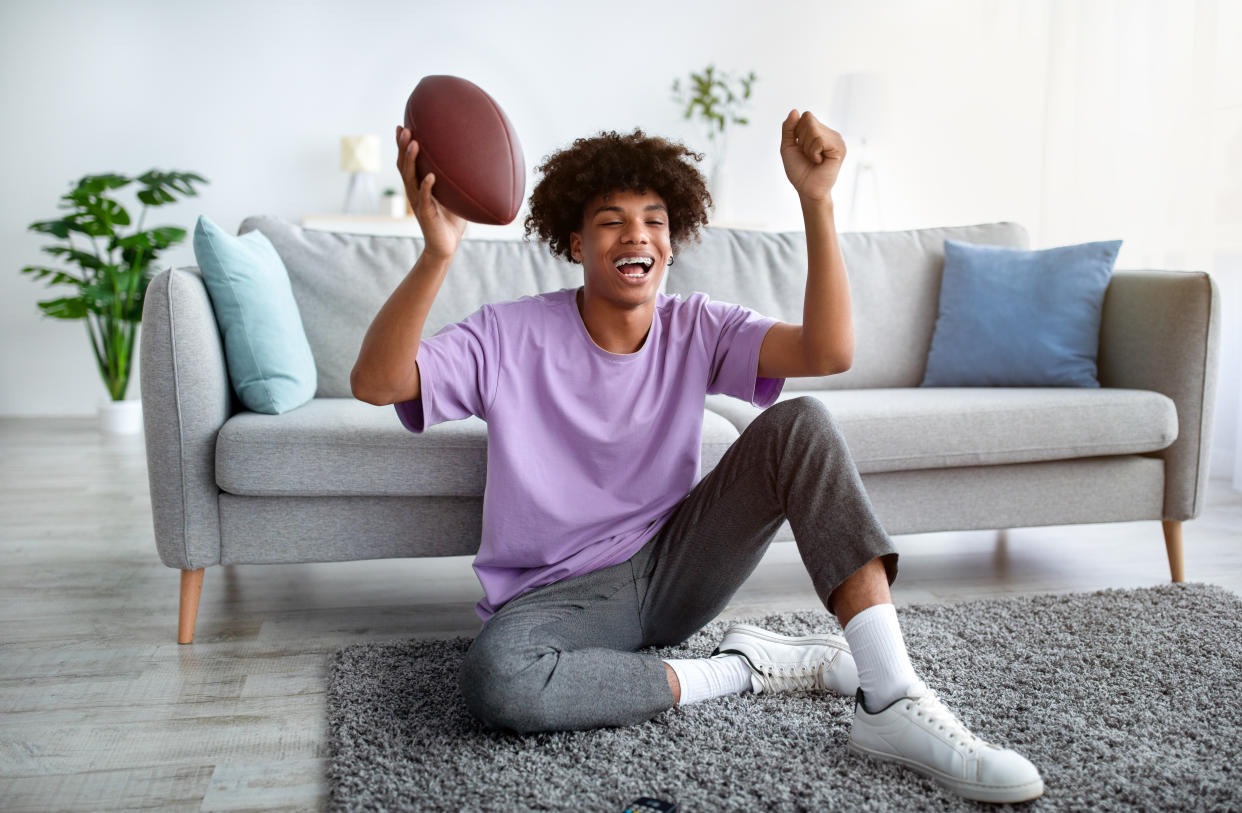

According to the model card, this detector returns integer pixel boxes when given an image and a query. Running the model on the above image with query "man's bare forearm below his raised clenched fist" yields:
[802,199,854,371]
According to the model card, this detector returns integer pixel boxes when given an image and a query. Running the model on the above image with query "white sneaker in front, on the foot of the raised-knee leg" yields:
[850,681,1043,802]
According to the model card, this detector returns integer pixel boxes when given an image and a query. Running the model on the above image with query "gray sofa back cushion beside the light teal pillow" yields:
[240,215,582,398]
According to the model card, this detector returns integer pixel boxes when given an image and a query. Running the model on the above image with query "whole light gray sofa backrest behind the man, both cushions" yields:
[238,215,1028,398]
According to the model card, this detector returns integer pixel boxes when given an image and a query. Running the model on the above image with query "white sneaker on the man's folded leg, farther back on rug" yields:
[712,624,858,698]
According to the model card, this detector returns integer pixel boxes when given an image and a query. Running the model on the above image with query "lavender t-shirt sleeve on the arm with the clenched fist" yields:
[699,299,785,407]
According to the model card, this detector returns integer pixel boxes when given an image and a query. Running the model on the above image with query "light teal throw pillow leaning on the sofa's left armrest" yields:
[194,216,318,415]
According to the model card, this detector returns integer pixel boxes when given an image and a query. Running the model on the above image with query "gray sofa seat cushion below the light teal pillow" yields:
[216,398,740,496]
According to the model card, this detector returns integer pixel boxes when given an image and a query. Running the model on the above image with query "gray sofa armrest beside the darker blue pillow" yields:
[1099,271,1221,520]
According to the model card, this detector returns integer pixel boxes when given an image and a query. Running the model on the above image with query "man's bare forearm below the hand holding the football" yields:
[349,252,452,403]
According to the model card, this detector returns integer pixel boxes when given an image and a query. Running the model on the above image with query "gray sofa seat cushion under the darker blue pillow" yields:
[707,387,1177,474]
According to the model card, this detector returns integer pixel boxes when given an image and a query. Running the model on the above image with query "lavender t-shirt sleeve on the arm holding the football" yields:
[394,305,501,432]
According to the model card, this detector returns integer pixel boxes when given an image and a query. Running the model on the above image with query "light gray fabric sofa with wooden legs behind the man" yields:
[140,216,1220,643]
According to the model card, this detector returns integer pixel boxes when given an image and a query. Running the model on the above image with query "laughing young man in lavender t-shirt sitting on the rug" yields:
[351,110,1043,802]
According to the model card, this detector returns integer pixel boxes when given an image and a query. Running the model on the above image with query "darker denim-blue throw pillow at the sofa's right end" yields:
[923,240,1122,387]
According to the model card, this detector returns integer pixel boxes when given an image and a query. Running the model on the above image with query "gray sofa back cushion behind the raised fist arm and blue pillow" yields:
[668,223,1028,391]
